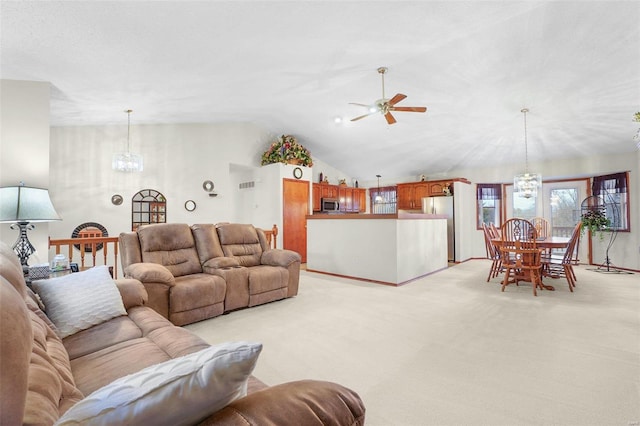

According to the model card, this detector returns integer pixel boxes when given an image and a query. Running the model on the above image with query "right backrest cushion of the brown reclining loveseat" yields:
[217,223,262,266]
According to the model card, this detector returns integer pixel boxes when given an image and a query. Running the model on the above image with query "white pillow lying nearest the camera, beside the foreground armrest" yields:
[56,342,262,425]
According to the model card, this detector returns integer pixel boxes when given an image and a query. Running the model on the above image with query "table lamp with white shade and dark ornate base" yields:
[0,184,60,272]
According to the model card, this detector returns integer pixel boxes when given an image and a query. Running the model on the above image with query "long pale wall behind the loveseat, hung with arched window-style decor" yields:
[50,122,270,238]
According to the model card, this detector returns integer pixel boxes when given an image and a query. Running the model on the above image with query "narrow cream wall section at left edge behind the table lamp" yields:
[0,80,52,265]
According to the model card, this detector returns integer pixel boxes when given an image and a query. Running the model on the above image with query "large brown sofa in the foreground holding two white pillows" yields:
[0,242,365,426]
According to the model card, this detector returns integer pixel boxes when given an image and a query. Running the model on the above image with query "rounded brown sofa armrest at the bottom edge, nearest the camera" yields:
[199,380,365,426]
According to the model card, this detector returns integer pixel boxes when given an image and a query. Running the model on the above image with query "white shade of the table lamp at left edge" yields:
[0,186,61,222]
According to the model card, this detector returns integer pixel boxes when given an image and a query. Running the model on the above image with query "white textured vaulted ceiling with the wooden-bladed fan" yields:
[0,0,640,180]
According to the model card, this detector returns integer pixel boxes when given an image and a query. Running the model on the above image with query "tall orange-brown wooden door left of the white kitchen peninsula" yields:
[282,179,309,263]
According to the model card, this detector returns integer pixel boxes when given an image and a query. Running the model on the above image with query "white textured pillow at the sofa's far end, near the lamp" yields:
[31,266,127,339]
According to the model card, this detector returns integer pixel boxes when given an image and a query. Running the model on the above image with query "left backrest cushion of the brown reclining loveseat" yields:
[138,223,202,277]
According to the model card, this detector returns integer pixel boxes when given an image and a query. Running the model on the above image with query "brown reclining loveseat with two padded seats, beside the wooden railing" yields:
[120,223,300,325]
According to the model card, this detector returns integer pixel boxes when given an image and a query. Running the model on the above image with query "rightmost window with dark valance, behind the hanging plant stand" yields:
[591,172,629,231]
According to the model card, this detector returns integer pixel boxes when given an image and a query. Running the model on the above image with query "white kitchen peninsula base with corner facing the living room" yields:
[307,213,447,286]
